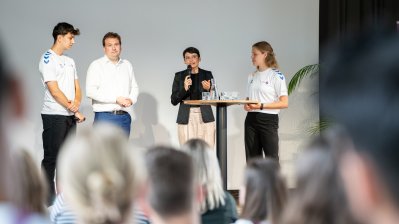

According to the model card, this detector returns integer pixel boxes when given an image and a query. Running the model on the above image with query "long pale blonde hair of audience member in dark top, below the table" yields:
[182,139,225,213]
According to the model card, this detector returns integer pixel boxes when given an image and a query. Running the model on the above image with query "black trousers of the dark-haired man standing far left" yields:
[42,114,76,204]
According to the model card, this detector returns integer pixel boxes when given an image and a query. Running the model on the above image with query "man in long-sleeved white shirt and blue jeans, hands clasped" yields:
[86,32,139,136]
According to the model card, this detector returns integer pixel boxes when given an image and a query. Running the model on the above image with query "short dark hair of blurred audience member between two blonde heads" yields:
[145,146,194,217]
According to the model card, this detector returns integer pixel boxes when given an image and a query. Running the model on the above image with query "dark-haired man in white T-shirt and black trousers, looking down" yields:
[39,23,85,203]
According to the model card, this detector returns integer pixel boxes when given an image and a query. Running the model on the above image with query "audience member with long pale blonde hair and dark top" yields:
[182,139,237,224]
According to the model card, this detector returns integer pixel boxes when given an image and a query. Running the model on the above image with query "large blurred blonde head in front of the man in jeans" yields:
[57,123,139,224]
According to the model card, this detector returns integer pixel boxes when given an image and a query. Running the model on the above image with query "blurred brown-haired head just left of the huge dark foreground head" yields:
[282,128,354,224]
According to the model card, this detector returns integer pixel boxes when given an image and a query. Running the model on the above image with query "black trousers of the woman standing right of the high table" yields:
[244,112,279,161]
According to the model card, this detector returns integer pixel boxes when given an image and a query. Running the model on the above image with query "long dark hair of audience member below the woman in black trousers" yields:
[241,158,287,223]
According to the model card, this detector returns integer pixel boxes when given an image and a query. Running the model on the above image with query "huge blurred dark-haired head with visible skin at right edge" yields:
[320,29,399,223]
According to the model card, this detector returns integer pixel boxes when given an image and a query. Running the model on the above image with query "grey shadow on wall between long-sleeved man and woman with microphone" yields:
[130,93,171,148]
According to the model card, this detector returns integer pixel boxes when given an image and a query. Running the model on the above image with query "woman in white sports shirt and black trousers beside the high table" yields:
[244,41,288,161]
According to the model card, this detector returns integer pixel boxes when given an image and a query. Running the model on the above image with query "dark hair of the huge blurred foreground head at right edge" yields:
[320,30,399,207]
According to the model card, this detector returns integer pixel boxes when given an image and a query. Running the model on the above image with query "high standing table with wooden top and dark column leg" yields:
[184,100,258,190]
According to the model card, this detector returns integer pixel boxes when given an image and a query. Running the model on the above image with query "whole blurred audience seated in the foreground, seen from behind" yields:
[0,27,399,224]
